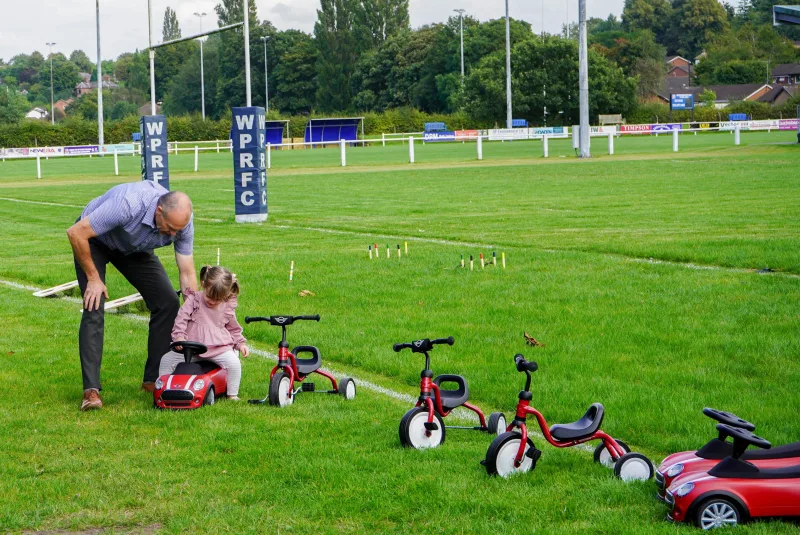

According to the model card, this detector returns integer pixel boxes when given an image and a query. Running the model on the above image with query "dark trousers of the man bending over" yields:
[75,238,180,390]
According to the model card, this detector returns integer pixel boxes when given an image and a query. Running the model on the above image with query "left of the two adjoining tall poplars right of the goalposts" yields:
[314,0,358,112]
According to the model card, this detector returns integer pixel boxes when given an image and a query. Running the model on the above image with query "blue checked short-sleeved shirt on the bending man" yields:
[81,180,194,255]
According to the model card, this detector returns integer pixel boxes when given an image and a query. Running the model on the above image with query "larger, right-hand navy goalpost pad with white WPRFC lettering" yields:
[231,106,267,223]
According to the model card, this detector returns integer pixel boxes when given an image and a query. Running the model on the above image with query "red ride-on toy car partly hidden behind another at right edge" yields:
[656,408,800,500]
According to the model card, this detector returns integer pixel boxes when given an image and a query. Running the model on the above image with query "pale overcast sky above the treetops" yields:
[0,0,624,61]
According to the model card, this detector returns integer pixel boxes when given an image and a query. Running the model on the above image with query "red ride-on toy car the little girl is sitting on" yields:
[153,340,228,409]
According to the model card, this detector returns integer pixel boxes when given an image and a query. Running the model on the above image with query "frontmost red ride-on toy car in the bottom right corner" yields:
[667,424,800,530]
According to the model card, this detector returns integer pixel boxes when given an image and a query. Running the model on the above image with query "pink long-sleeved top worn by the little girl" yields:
[172,288,247,358]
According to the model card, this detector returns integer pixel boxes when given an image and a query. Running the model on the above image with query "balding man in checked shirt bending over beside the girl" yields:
[67,181,197,411]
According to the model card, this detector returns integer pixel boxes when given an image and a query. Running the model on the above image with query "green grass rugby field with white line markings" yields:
[0,132,800,534]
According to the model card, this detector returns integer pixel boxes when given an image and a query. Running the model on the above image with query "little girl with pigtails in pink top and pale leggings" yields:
[158,266,250,401]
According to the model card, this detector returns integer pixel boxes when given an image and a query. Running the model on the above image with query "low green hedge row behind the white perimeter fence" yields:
[0,99,800,147]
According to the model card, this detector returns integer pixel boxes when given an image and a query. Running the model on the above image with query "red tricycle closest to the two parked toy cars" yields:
[481,355,653,481]
